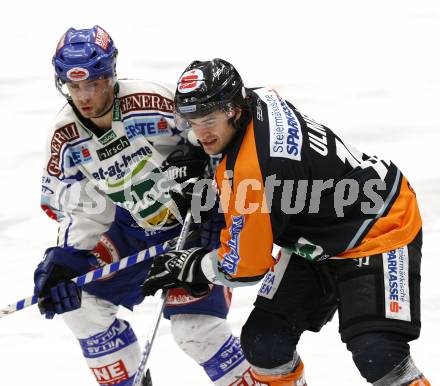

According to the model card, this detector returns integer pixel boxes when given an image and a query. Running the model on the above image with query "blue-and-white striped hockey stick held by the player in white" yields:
[0,243,168,318]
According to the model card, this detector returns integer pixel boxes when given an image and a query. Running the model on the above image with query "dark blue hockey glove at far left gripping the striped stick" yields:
[34,247,98,319]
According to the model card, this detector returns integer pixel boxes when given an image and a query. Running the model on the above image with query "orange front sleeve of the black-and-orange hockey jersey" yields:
[216,124,275,278]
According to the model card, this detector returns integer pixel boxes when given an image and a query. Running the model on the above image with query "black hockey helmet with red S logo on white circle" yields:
[174,58,246,119]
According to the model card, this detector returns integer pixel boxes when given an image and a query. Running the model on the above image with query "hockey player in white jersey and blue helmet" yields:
[34,26,254,386]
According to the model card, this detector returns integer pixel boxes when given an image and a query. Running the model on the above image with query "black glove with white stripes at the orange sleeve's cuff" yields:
[142,248,210,297]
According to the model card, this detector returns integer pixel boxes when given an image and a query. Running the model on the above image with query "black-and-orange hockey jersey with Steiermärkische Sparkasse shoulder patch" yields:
[216,88,422,284]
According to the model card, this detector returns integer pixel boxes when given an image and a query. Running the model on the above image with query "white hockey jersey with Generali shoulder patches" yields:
[41,80,186,250]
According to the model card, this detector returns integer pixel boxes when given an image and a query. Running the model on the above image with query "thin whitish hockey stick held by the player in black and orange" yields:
[132,210,191,386]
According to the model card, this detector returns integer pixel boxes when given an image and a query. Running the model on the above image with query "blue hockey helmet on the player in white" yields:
[52,25,118,91]
